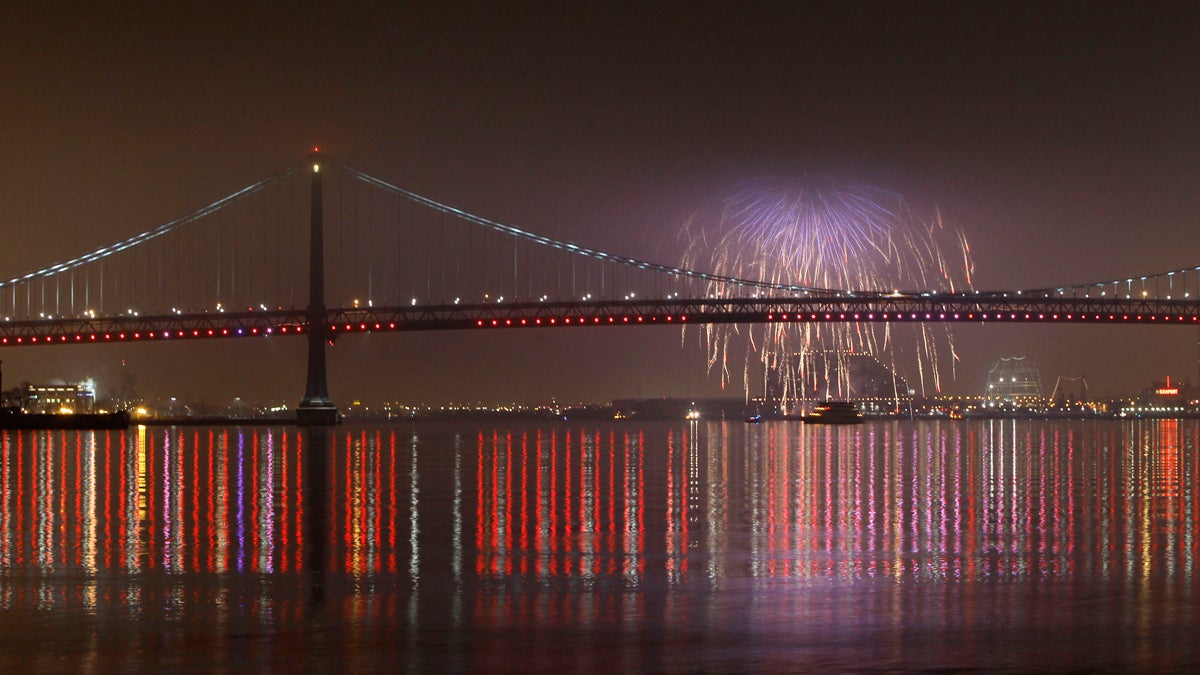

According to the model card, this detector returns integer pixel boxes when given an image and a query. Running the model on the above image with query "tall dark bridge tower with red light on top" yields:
[296,149,341,426]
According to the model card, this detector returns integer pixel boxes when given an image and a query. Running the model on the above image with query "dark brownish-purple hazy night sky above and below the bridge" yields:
[0,2,1200,402]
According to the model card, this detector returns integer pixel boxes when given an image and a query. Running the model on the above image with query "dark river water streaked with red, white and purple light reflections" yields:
[0,420,1200,673]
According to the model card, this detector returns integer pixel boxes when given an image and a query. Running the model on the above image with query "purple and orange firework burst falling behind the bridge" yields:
[682,179,973,406]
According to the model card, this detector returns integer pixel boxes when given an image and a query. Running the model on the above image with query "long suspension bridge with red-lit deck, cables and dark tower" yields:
[0,151,1200,424]
